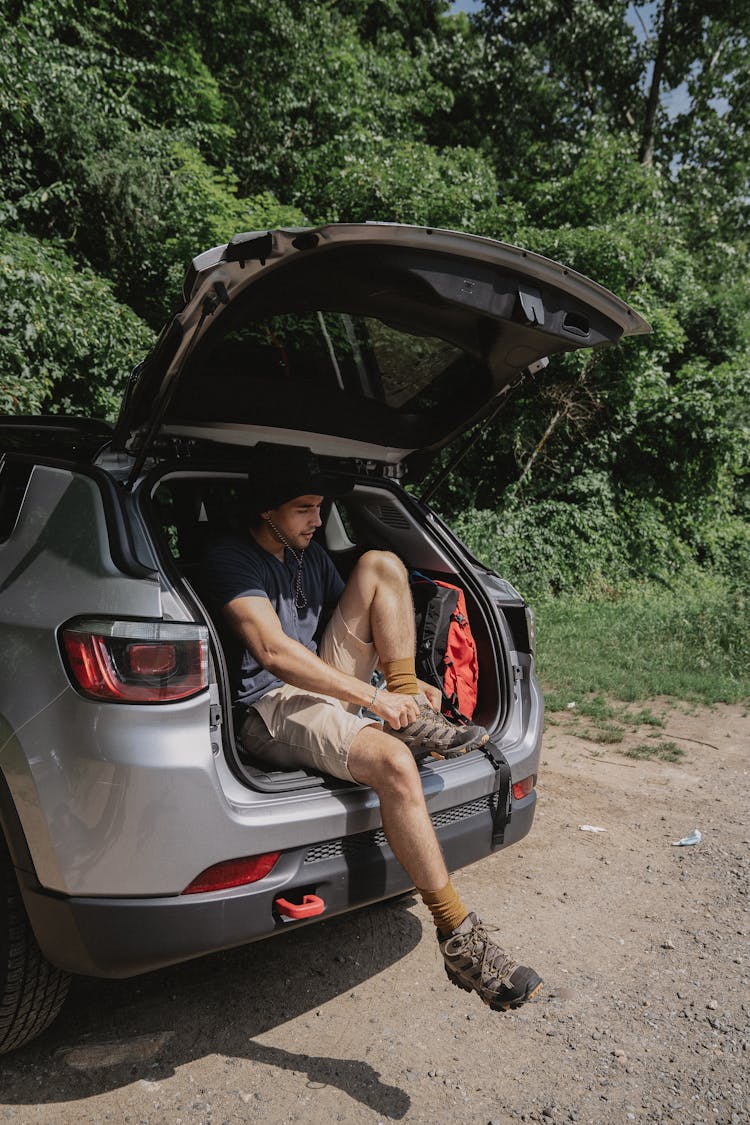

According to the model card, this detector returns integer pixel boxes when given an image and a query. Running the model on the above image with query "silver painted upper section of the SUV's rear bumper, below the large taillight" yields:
[0,657,542,897]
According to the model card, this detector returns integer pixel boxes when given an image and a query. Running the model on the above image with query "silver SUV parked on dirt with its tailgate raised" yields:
[0,224,648,1051]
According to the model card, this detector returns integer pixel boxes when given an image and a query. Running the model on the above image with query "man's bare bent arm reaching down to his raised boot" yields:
[224,597,417,728]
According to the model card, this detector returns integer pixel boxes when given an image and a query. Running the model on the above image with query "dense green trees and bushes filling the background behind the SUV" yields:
[0,0,750,607]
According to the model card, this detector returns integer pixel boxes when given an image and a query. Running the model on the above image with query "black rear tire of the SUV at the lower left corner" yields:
[0,833,70,1054]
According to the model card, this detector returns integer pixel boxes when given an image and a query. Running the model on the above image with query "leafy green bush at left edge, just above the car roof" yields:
[0,234,153,420]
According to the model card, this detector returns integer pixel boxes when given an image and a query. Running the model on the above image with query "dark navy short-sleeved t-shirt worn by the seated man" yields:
[204,536,344,707]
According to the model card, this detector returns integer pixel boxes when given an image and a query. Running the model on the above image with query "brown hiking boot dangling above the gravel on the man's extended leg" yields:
[437,914,542,1011]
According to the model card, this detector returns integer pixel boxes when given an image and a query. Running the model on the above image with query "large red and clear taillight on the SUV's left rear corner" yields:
[61,619,208,703]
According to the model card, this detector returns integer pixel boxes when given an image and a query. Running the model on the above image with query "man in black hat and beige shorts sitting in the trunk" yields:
[207,455,542,1009]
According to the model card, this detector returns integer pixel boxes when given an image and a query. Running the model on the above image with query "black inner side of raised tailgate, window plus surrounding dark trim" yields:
[170,248,498,449]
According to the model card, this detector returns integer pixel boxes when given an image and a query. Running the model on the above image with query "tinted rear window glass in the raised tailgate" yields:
[171,309,491,449]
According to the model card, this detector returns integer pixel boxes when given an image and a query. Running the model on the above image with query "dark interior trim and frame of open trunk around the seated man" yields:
[142,456,530,793]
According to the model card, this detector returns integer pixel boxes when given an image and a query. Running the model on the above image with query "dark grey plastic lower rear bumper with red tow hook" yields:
[19,792,536,978]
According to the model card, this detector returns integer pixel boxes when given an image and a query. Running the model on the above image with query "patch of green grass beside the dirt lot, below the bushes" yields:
[534,574,750,702]
